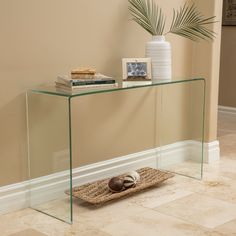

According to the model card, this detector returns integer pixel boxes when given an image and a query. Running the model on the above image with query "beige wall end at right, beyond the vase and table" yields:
[193,0,222,142]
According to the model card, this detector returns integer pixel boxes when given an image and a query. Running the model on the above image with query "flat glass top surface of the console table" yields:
[28,78,205,98]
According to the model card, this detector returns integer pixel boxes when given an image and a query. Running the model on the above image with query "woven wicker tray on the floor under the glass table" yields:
[66,167,174,204]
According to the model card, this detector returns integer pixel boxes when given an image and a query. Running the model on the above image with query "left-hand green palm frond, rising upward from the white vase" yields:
[128,0,165,35]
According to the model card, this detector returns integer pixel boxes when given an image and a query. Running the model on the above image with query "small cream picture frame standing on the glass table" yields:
[122,58,152,81]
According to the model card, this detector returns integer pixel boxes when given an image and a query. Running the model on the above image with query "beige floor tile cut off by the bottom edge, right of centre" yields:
[102,210,214,236]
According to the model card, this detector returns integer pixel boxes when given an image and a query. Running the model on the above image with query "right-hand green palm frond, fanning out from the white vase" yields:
[168,3,216,41]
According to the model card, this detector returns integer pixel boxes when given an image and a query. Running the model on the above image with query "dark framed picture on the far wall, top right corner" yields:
[222,0,236,26]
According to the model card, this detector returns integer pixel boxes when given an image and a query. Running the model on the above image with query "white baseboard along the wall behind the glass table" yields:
[0,140,219,214]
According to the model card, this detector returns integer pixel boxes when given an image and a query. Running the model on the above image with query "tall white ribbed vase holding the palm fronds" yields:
[146,36,171,83]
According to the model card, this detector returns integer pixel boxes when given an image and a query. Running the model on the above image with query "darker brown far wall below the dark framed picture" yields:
[219,26,236,107]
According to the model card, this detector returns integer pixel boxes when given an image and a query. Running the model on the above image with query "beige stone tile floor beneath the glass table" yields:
[0,111,236,236]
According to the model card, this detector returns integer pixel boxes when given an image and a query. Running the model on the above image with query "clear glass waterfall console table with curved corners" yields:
[27,78,205,223]
